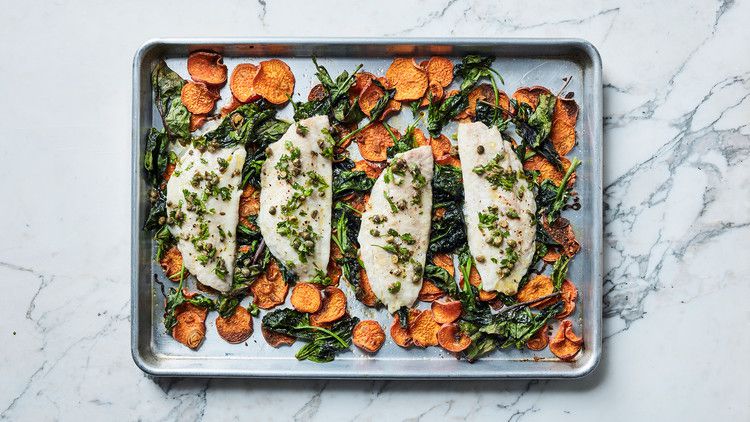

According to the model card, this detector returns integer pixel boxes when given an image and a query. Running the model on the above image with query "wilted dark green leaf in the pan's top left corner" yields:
[151,60,190,144]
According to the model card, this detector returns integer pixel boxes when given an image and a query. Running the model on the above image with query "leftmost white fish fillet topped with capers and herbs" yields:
[167,146,245,292]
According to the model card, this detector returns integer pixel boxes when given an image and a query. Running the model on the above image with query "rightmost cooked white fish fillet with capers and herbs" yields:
[458,122,536,295]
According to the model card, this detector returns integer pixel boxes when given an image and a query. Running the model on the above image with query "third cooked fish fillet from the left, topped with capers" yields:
[358,146,433,312]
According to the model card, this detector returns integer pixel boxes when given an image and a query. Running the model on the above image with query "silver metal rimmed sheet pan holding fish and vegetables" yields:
[131,38,602,379]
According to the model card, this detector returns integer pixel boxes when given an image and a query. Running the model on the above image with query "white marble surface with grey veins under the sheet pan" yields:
[0,0,750,421]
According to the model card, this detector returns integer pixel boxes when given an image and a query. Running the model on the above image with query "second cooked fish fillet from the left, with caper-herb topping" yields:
[258,116,333,282]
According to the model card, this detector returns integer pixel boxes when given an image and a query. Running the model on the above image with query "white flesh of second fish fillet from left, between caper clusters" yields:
[258,116,333,282]
